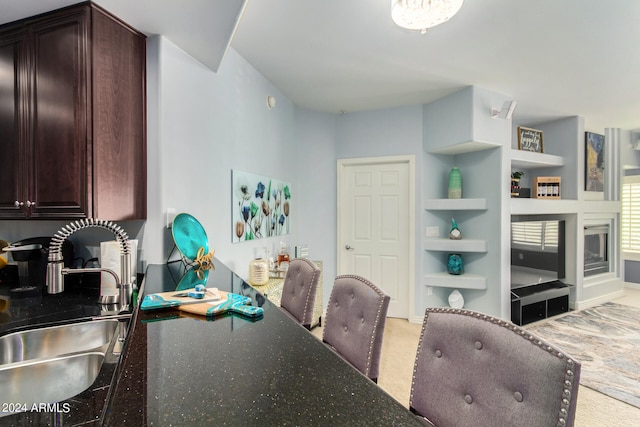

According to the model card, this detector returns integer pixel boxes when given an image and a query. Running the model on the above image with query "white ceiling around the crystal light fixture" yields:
[0,0,640,131]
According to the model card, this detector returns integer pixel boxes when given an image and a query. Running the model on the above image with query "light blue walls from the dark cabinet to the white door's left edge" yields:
[143,37,348,301]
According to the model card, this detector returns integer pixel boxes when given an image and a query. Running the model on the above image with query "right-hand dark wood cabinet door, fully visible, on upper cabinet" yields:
[27,7,91,218]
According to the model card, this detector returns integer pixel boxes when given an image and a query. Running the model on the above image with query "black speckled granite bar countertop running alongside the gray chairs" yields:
[103,259,420,427]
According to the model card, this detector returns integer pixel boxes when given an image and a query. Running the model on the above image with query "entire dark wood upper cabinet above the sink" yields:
[0,3,147,220]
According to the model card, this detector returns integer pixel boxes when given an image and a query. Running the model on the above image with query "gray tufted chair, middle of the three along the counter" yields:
[322,275,390,382]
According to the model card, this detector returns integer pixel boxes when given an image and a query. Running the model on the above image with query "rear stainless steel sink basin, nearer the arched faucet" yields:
[0,319,118,365]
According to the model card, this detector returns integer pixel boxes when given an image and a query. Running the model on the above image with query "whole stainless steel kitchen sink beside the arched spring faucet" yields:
[0,319,122,417]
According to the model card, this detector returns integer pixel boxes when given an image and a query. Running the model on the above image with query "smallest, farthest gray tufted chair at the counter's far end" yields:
[280,258,320,329]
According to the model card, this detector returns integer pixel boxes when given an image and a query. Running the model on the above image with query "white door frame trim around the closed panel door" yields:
[336,154,416,322]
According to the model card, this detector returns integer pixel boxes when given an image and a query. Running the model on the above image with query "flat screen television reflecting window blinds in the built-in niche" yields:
[511,220,565,289]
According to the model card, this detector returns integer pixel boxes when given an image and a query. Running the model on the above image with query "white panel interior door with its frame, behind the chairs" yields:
[337,157,414,319]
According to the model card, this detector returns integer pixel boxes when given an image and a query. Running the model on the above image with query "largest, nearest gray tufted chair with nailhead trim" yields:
[409,308,581,427]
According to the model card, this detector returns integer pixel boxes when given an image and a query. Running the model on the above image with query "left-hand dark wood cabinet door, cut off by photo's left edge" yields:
[0,30,27,218]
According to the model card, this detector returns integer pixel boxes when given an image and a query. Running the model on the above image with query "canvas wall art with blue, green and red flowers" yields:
[231,170,291,243]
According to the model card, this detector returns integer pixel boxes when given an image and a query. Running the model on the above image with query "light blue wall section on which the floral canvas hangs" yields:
[143,37,302,278]
